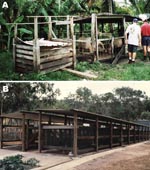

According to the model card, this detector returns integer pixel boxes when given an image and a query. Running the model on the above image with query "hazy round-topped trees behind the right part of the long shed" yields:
[57,87,150,121]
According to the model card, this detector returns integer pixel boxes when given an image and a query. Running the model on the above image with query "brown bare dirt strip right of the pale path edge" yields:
[73,142,150,170]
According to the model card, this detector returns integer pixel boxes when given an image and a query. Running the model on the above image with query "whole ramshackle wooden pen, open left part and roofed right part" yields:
[13,14,138,73]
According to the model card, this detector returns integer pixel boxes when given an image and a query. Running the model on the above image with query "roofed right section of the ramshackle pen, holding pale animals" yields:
[74,13,140,64]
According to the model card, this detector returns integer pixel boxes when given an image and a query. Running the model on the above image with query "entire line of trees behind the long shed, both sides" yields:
[0,82,150,121]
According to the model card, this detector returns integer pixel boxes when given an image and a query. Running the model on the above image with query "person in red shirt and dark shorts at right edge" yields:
[141,18,150,61]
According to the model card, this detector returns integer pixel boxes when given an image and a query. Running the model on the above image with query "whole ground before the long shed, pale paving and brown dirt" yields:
[0,141,150,170]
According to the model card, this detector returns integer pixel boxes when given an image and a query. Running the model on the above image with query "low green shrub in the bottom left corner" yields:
[0,155,39,170]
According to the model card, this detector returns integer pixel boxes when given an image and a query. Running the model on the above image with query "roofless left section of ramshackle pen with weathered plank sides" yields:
[13,16,76,73]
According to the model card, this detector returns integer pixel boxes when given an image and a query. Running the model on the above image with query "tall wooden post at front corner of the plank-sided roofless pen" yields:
[33,17,40,72]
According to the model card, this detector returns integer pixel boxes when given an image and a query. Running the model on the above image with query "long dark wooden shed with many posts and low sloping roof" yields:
[0,109,150,156]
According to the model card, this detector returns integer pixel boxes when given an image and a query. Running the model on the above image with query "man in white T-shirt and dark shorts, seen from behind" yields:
[125,18,141,64]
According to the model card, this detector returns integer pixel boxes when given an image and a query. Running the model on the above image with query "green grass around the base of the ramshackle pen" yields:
[0,52,150,81]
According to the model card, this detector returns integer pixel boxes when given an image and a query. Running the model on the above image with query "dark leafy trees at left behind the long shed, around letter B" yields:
[0,82,60,113]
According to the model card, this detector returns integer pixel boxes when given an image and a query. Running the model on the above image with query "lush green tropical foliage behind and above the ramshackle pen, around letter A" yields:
[0,0,150,50]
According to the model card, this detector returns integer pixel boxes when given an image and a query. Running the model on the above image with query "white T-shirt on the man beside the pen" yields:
[126,23,141,46]
